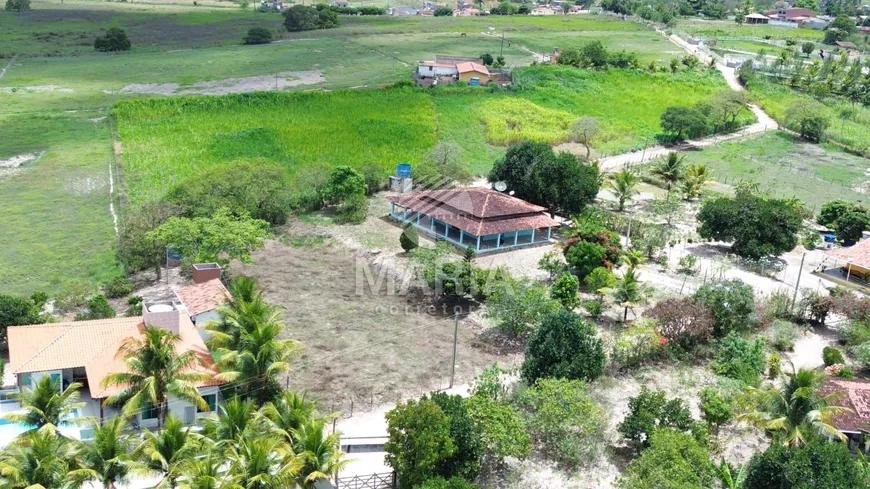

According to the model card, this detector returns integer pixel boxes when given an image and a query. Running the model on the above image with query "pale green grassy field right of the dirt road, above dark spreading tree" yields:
[686,132,870,209]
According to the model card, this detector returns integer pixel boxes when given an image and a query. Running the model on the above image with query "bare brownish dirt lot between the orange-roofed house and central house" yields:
[233,222,516,415]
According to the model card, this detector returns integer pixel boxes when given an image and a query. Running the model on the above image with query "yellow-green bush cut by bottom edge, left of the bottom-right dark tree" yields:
[619,428,718,489]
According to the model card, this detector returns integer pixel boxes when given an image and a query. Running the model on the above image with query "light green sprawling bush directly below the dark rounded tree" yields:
[516,379,607,467]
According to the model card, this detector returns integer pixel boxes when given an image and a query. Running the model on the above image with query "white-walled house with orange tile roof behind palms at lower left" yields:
[3,303,223,430]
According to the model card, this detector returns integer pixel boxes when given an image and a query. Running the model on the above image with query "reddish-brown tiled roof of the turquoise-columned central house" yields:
[386,187,559,236]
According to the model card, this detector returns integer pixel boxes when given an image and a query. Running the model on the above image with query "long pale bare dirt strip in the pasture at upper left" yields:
[116,70,326,95]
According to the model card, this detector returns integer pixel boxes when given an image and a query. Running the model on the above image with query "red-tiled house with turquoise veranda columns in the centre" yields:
[386,188,559,253]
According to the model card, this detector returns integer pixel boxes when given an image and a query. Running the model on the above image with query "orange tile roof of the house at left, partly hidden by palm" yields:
[7,313,222,399]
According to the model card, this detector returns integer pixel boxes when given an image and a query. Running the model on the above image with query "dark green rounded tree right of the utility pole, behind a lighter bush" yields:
[522,309,606,384]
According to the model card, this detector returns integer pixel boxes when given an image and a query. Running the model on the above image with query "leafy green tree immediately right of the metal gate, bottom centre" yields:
[384,399,456,487]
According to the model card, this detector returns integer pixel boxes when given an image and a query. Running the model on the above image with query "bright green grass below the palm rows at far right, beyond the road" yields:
[749,77,870,154]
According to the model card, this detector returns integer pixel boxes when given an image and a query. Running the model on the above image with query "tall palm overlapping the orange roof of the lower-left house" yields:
[103,326,211,428]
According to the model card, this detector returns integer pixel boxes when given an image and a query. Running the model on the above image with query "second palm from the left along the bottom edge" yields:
[73,416,138,489]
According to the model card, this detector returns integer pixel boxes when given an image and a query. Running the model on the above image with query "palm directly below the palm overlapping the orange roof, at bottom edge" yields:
[140,416,203,489]
